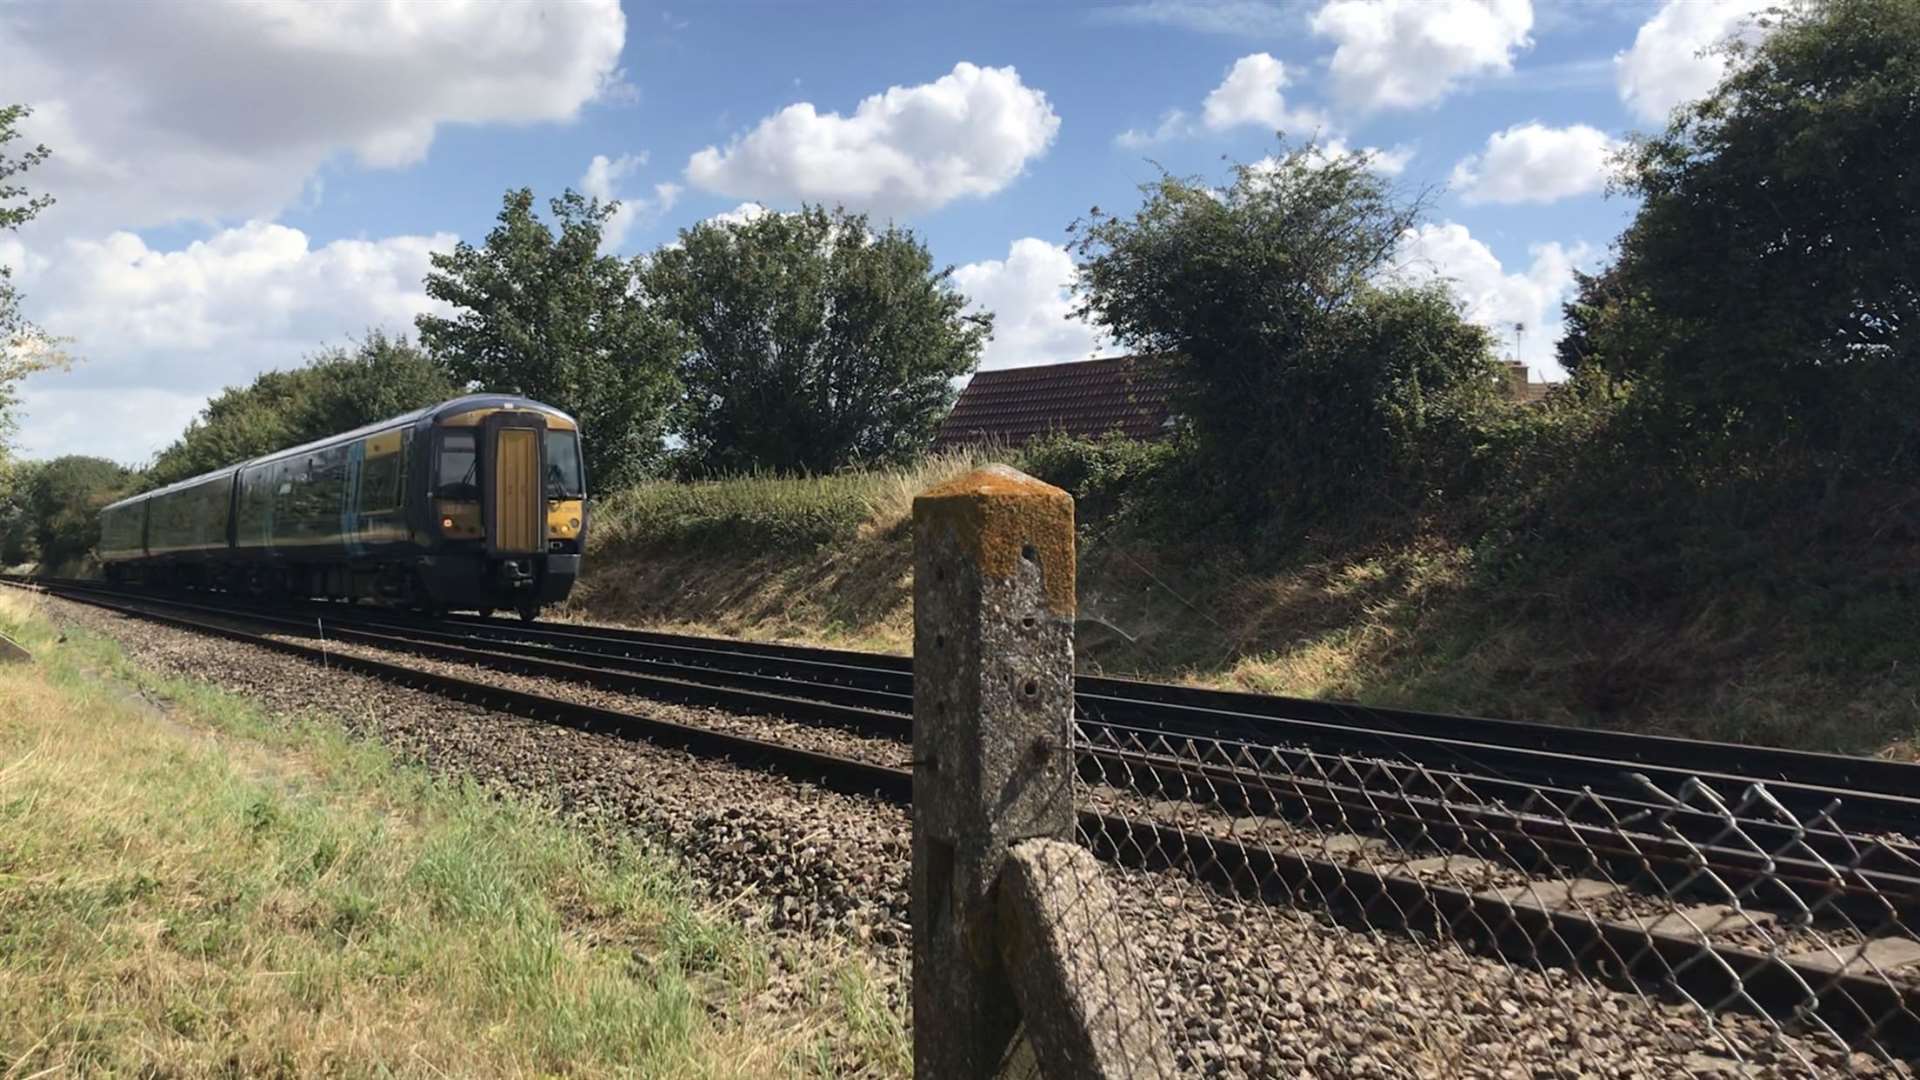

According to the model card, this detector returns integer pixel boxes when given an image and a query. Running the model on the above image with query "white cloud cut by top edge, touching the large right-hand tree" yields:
[1613,0,1778,123]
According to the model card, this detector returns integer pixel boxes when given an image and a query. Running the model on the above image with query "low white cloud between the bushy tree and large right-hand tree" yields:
[1394,221,1594,379]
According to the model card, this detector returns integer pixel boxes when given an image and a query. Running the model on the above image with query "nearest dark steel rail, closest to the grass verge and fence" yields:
[11,576,1920,1055]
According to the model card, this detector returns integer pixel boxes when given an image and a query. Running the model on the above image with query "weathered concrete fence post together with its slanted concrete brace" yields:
[912,465,1171,1080]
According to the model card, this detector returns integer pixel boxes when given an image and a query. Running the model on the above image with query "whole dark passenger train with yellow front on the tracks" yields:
[96,394,588,621]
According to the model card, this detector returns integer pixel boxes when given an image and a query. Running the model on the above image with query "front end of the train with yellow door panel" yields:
[420,398,586,621]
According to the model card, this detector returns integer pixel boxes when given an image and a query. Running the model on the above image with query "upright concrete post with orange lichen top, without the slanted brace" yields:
[912,465,1073,1078]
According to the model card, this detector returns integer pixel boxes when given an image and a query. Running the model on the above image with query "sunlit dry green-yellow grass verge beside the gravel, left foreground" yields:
[0,590,906,1076]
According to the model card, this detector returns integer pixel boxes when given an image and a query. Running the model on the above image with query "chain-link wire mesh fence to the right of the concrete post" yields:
[1073,715,1920,1076]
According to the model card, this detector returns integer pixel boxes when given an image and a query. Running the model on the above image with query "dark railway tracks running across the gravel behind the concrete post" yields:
[15,582,1920,1053]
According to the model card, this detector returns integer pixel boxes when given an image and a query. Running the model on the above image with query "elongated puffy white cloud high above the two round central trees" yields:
[687,61,1060,213]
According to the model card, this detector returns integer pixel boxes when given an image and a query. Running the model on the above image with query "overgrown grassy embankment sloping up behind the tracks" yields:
[572,457,1920,755]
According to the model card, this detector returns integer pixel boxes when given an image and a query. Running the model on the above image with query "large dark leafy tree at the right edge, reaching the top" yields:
[1576,0,1920,471]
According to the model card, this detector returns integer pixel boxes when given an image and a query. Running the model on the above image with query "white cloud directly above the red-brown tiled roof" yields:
[954,236,1102,367]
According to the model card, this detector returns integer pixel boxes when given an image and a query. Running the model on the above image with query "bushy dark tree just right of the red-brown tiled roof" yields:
[1073,144,1498,517]
